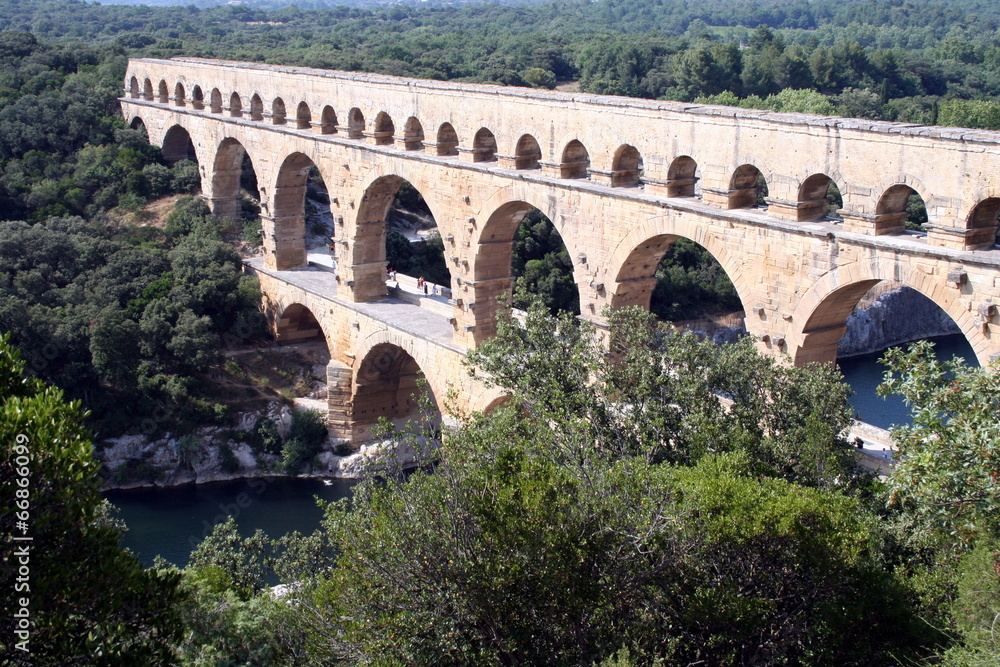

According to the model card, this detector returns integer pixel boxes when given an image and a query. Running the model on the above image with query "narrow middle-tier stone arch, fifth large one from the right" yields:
[267,152,327,270]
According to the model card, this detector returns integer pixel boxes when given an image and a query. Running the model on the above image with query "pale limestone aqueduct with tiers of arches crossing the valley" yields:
[121,58,1000,438]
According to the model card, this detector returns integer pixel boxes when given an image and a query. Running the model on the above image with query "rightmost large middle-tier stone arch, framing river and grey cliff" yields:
[787,259,989,366]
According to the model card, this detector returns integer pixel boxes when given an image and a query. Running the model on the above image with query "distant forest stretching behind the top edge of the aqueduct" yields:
[0,0,1000,128]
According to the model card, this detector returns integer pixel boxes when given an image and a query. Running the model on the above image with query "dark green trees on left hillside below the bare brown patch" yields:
[0,198,261,434]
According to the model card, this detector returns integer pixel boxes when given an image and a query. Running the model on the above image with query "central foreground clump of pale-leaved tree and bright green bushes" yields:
[272,303,926,665]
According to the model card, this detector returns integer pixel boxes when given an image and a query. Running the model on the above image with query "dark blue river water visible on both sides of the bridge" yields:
[106,335,975,566]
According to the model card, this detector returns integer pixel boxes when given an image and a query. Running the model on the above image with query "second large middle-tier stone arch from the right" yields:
[606,218,754,322]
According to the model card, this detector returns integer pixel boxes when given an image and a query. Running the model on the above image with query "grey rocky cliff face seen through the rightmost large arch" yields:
[837,287,961,357]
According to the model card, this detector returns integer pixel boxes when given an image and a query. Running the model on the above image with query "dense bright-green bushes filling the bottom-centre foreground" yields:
[306,426,916,665]
